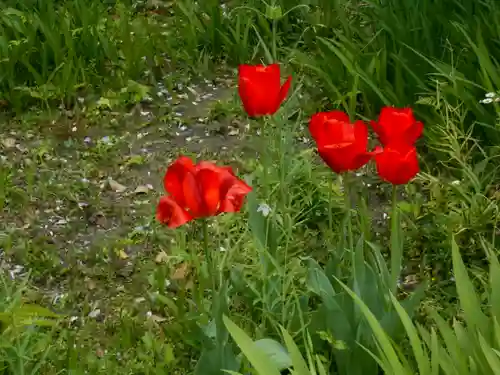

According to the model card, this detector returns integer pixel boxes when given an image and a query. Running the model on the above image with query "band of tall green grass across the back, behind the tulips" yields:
[0,0,500,148]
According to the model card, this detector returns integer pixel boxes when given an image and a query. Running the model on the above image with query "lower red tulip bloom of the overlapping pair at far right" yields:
[373,145,420,185]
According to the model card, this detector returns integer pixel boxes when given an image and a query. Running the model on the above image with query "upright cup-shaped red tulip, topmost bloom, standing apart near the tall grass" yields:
[238,64,292,117]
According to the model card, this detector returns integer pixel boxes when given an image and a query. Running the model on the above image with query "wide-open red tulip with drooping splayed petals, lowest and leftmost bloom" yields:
[156,156,252,228]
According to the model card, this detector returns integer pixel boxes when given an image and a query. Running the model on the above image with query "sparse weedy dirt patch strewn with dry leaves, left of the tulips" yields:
[0,72,252,314]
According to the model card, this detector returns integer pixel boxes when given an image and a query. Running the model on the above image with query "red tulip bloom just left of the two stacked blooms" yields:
[309,111,372,173]
